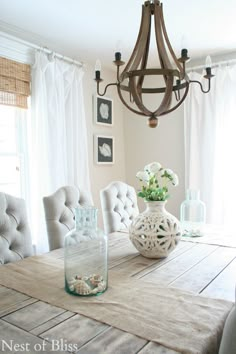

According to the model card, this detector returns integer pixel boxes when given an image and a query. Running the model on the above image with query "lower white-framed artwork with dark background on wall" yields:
[94,135,115,164]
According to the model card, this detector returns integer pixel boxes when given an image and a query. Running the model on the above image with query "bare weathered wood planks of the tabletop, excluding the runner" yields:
[0,233,236,354]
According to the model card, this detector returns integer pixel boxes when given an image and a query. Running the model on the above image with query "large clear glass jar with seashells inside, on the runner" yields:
[64,207,108,296]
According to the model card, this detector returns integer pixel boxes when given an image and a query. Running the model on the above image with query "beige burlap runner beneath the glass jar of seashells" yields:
[0,256,232,354]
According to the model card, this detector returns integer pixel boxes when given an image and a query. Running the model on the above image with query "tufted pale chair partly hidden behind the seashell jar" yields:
[43,186,92,251]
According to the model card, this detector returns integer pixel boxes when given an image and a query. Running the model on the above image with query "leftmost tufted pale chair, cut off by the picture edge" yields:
[0,192,33,264]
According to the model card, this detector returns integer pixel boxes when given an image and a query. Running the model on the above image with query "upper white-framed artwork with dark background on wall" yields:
[94,95,114,126]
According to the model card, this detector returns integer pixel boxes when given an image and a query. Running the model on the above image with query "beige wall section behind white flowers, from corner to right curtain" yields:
[124,82,184,217]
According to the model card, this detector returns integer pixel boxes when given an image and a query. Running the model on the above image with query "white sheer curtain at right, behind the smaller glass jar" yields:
[185,65,236,227]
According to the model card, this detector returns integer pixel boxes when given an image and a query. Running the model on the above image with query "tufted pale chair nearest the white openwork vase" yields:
[100,181,139,234]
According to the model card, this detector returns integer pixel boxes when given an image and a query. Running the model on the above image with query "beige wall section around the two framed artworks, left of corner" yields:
[83,65,126,227]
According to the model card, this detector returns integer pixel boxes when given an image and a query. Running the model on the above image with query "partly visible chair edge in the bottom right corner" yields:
[219,289,236,354]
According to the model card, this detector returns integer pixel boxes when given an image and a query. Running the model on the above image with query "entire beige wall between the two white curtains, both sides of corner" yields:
[83,65,184,227]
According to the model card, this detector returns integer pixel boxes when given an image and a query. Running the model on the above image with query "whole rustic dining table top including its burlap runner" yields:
[0,231,236,354]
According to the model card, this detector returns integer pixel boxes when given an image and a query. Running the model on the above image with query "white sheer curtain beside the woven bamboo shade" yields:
[30,51,90,252]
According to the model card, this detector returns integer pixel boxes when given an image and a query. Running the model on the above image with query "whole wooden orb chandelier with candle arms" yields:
[95,0,214,128]
